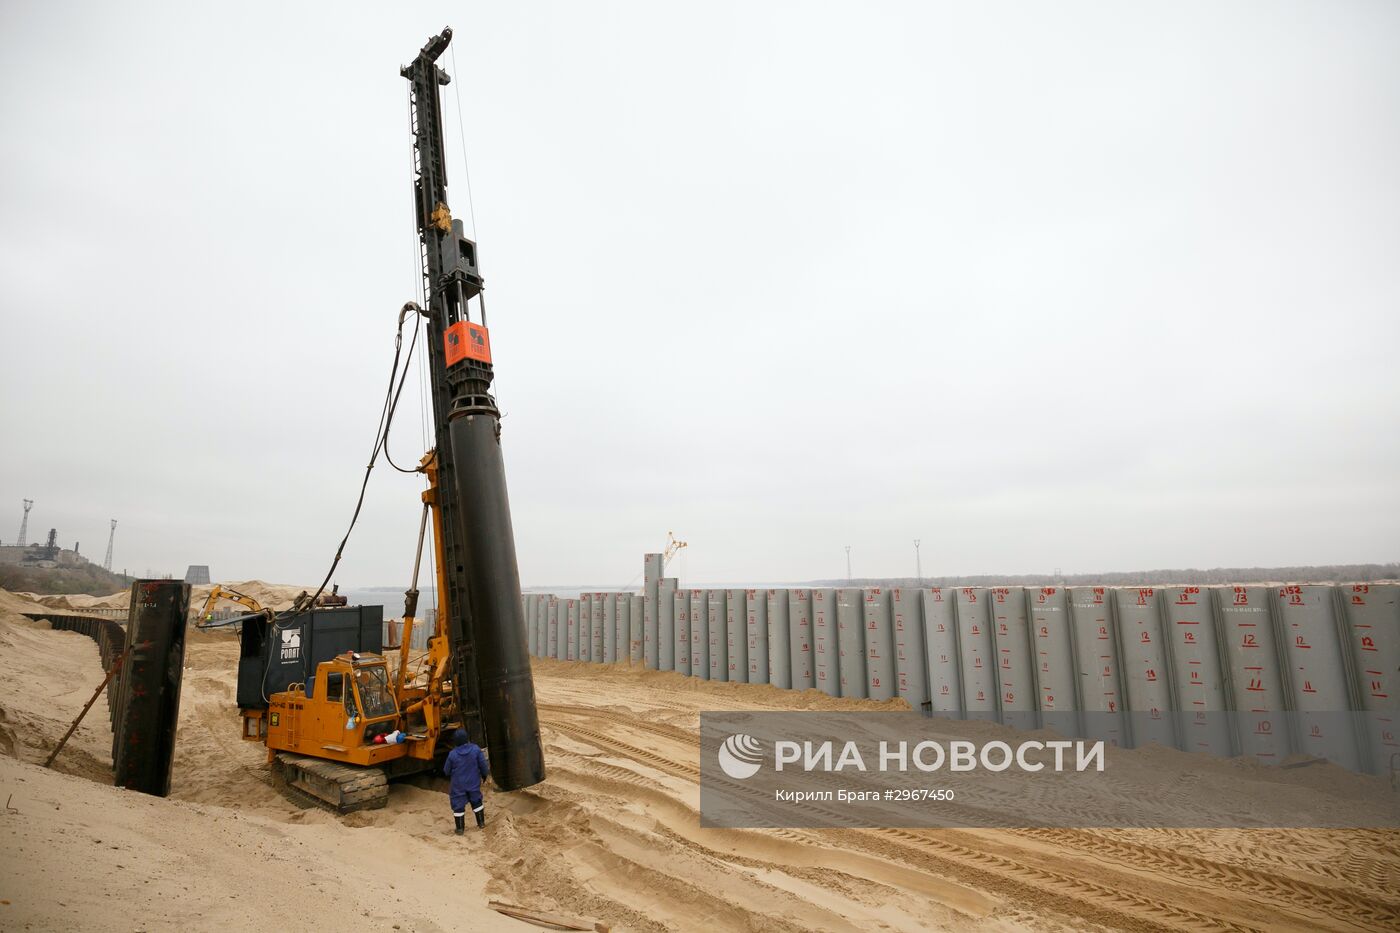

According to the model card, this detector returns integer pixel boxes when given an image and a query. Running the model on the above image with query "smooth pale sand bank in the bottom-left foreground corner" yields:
[0,756,515,933]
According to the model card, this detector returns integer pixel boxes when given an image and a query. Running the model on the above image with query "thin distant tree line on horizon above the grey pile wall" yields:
[811,563,1400,587]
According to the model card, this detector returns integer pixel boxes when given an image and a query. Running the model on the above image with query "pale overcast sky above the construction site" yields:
[0,0,1400,586]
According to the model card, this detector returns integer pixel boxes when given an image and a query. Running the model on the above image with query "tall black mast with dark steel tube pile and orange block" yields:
[399,28,545,790]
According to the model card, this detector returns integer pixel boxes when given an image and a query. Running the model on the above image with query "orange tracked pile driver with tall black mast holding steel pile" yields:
[239,29,545,811]
